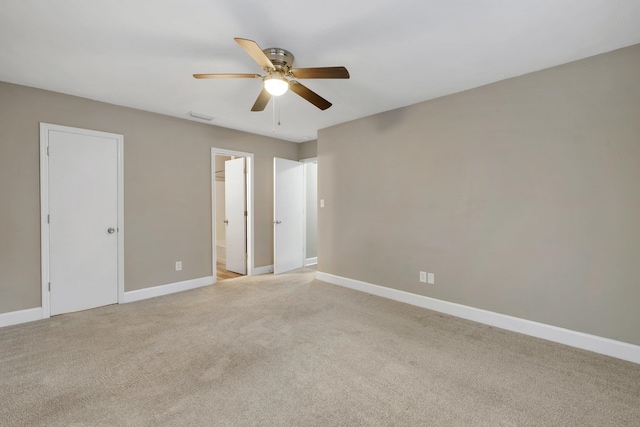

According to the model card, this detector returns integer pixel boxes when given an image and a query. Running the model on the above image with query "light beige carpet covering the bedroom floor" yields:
[0,269,640,426]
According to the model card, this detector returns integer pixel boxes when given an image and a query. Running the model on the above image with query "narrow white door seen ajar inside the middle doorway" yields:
[224,157,247,274]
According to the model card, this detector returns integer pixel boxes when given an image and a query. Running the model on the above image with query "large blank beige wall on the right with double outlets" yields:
[318,45,640,344]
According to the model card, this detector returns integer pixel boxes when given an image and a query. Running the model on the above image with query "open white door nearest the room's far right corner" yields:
[273,157,304,274]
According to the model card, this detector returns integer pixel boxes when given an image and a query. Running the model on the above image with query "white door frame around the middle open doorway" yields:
[211,147,255,283]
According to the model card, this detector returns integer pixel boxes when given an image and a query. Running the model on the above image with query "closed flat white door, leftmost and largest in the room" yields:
[48,128,118,315]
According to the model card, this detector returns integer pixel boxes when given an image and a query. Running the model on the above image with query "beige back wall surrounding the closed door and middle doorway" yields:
[0,83,298,313]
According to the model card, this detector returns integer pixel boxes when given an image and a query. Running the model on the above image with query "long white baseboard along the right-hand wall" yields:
[316,271,640,363]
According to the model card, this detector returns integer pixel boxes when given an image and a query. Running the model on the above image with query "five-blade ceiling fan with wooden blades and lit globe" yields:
[193,37,349,111]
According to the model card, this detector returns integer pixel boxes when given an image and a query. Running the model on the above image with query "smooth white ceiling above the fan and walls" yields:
[0,0,640,142]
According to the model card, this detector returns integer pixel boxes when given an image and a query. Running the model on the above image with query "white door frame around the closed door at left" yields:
[40,122,125,319]
